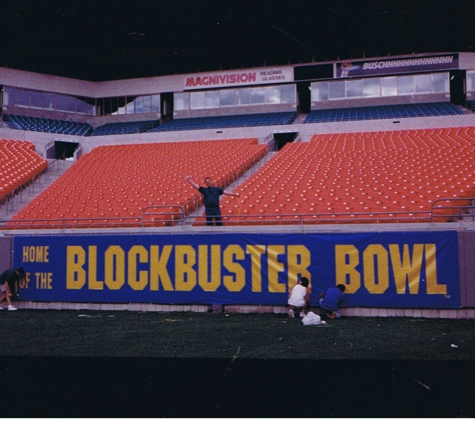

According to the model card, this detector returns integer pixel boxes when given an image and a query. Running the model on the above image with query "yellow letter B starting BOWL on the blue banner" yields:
[335,245,361,293]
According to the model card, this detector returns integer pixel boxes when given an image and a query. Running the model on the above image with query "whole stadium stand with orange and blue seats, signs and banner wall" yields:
[0,52,475,318]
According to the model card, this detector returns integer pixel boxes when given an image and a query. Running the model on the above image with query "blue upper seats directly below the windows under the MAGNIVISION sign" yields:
[150,111,296,132]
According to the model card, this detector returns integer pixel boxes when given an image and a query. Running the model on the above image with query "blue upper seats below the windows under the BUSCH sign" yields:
[304,102,466,123]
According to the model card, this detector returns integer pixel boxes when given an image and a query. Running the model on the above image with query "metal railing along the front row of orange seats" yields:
[0,197,475,230]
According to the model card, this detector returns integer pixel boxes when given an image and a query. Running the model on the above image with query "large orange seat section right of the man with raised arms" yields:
[214,127,475,224]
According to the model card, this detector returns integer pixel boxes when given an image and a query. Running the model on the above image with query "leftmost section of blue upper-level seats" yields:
[3,114,92,136]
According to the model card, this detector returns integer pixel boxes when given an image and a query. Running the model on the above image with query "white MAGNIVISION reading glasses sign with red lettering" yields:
[183,67,294,90]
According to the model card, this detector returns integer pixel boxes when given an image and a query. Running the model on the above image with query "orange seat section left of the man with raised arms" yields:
[8,138,267,227]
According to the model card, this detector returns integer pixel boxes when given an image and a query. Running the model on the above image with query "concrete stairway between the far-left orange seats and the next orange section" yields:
[0,160,74,226]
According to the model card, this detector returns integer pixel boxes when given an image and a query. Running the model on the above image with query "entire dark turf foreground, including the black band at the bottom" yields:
[0,310,475,418]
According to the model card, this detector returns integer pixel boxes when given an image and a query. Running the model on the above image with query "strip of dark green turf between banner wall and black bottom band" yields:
[0,310,475,360]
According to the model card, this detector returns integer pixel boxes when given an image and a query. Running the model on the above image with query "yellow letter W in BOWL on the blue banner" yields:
[389,244,424,295]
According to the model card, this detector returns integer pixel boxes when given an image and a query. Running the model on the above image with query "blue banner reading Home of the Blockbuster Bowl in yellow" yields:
[14,232,460,308]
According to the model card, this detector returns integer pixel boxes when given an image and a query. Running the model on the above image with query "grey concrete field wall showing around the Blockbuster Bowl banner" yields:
[0,223,475,319]
